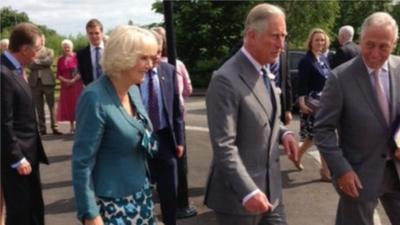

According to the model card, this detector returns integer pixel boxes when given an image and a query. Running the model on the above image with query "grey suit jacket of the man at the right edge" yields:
[314,56,400,200]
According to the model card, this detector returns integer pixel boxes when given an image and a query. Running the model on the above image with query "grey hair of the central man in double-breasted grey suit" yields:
[244,3,285,33]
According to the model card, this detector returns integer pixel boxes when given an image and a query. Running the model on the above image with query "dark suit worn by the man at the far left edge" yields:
[0,54,48,225]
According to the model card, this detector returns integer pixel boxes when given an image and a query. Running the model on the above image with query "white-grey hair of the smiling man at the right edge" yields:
[361,12,399,41]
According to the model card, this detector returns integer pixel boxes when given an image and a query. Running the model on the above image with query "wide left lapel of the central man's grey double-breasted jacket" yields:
[236,51,272,117]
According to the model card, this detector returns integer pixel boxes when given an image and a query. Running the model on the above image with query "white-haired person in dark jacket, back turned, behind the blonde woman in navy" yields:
[331,25,360,69]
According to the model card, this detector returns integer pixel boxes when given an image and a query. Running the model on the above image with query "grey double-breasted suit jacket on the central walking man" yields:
[205,51,287,214]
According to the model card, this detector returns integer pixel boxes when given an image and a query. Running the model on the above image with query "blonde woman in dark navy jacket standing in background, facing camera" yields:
[295,28,330,181]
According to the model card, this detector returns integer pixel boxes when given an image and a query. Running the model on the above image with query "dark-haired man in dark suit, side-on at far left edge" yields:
[0,23,48,225]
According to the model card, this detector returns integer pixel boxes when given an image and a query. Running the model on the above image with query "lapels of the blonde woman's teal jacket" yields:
[99,76,144,133]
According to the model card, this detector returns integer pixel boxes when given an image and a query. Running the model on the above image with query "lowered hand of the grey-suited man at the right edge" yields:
[337,170,363,198]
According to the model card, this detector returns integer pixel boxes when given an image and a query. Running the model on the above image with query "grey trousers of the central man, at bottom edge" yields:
[215,201,287,225]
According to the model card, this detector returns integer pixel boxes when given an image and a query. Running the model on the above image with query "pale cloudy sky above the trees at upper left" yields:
[0,0,164,36]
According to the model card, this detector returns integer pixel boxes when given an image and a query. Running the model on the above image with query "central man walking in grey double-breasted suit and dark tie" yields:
[205,3,298,225]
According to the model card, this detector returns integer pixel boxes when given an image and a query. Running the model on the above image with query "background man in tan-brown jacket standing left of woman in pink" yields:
[28,35,61,135]
